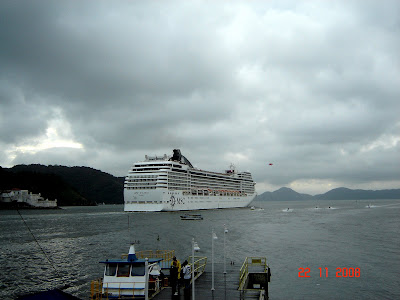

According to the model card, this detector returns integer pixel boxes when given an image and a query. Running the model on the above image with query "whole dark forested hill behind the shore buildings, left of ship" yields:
[0,164,124,206]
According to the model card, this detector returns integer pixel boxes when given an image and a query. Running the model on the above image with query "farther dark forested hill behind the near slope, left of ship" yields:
[4,164,124,205]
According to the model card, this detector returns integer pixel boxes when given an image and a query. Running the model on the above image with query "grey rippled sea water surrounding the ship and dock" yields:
[0,200,400,299]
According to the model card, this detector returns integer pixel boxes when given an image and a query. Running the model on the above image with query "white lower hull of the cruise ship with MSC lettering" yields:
[124,189,256,211]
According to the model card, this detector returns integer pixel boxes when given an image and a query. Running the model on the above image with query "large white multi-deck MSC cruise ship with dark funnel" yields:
[124,149,257,211]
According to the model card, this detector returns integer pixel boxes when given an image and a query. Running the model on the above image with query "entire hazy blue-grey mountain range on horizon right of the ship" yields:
[255,187,400,201]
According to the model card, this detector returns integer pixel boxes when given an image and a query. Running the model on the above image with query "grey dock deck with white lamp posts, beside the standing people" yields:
[153,262,243,300]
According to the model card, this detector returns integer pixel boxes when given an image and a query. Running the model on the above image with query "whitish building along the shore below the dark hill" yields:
[0,189,57,208]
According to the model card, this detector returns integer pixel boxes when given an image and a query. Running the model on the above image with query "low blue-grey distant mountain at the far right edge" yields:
[314,187,400,200]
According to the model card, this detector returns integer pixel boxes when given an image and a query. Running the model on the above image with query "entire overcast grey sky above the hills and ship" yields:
[0,0,400,194]
